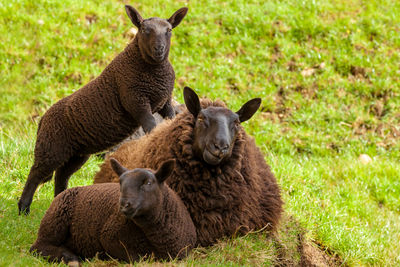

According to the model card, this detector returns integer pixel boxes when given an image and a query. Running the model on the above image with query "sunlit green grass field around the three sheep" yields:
[0,0,400,266]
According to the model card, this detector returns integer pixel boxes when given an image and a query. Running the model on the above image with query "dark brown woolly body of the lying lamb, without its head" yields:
[31,183,196,262]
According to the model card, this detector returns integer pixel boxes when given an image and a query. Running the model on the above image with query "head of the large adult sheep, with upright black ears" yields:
[183,87,261,166]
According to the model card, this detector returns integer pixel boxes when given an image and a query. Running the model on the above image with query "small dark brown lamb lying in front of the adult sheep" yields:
[30,159,196,265]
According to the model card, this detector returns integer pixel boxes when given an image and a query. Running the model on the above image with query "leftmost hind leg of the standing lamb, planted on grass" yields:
[18,163,54,215]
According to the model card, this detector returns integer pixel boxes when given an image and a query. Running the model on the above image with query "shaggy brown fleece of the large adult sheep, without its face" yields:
[94,99,283,246]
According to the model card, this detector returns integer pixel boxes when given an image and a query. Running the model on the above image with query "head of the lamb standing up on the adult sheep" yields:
[125,5,188,64]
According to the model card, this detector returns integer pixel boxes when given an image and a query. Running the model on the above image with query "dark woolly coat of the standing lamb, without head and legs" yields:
[35,39,175,159]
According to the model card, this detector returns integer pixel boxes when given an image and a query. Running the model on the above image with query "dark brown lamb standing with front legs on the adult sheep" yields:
[18,5,188,214]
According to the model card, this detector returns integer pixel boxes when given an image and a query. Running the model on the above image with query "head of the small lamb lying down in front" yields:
[110,158,175,219]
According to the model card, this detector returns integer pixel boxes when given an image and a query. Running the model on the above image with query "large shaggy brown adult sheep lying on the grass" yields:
[94,87,283,246]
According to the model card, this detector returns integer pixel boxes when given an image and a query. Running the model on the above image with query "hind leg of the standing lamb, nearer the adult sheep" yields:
[54,155,89,197]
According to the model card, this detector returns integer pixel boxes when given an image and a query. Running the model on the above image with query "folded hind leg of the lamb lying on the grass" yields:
[30,242,80,264]
